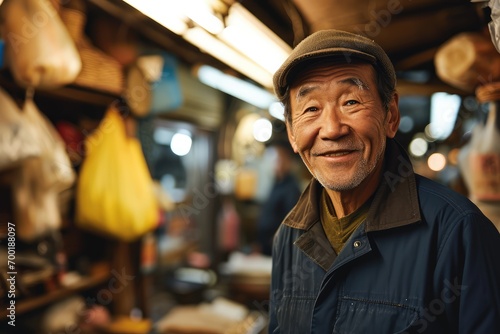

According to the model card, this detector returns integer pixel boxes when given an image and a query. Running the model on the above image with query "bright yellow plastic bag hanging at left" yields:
[76,107,159,241]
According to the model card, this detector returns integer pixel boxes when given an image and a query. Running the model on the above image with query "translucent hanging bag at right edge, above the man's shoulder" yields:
[459,83,500,231]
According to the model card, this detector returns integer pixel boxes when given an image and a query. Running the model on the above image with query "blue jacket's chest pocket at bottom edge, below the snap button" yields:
[333,297,418,334]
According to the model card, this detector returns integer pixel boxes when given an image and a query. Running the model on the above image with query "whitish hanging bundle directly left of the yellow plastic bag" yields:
[12,97,76,241]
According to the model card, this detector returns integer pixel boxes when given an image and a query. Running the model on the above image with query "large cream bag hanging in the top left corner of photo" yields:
[0,0,82,88]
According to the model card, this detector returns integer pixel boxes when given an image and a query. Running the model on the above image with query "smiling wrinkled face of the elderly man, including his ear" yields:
[287,63,399,191]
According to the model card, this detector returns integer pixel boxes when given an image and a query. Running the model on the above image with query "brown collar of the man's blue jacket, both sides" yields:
[283,139,421,232]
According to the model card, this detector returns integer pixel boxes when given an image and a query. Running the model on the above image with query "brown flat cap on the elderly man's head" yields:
[273,29,396,99]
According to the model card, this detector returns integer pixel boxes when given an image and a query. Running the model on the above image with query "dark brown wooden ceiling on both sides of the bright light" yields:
[88,0,489,91]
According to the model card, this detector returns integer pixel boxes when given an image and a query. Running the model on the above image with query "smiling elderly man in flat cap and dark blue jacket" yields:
[269,30,500,334]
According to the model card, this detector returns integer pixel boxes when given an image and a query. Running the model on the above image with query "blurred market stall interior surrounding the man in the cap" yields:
[0,0,500,333]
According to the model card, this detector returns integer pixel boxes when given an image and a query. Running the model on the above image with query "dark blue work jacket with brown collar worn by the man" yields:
[269,140,500,334]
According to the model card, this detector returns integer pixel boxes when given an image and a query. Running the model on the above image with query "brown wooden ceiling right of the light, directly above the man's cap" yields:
[248,0,486,70]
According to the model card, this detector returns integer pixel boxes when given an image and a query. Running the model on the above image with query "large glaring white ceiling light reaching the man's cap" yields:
[123,0,292,88]
